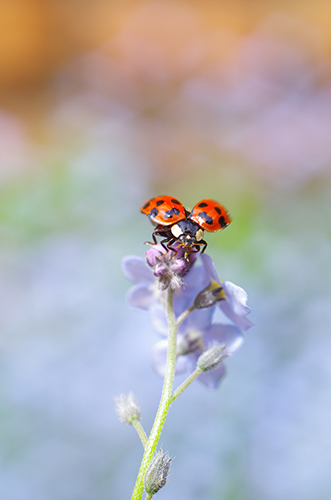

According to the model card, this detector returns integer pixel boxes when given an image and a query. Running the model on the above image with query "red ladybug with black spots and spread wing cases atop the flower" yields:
[141,196,231,259]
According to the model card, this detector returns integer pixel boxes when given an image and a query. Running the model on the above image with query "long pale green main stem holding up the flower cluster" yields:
[132,287,177,500]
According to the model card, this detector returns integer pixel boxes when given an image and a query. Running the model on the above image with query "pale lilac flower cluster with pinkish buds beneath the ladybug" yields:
[123,245,253,388]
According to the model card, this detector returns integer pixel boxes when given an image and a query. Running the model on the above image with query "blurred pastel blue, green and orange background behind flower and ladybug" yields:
[0,0,331,500]
